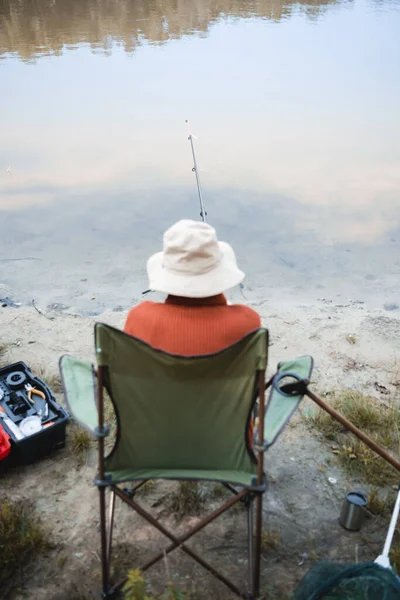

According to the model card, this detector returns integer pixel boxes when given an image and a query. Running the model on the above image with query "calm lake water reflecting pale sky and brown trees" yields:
[0,0,400,313]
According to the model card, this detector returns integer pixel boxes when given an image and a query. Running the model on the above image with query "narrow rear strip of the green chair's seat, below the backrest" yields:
[106,469,256,488]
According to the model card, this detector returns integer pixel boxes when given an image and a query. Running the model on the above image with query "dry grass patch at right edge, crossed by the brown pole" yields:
[306,390,400,486]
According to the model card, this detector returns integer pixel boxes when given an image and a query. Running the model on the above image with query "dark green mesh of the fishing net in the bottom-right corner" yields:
[293,562,400,600]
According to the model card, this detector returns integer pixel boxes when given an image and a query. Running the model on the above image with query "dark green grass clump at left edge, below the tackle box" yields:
[0,497,49,592]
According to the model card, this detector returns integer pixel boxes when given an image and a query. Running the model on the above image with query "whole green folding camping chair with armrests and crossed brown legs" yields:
[60,323,312,599]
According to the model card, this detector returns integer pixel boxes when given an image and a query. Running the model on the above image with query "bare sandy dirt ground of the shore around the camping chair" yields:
[0,299,400,600]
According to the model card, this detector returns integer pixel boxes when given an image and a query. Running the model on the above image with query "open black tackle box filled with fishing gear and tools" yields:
[0,361,68,467]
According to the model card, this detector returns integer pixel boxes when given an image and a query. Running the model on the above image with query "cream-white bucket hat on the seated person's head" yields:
[147,219,244,298]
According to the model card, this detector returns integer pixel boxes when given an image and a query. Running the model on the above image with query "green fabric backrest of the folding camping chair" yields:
[95,323,268,473]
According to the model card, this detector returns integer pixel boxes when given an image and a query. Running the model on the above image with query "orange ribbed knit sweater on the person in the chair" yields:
[124,294,261,356]
